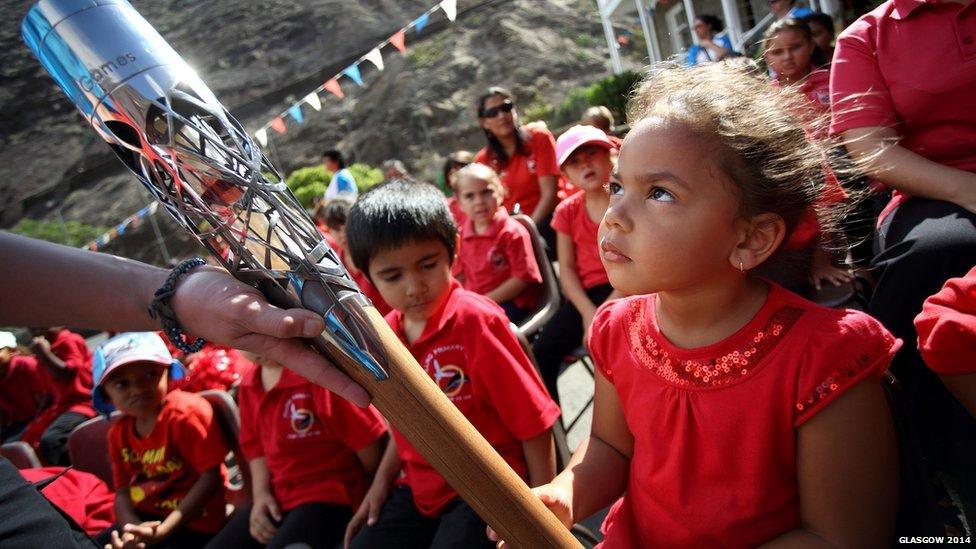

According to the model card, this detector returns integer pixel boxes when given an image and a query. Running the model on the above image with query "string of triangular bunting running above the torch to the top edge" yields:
[254,0,457,147]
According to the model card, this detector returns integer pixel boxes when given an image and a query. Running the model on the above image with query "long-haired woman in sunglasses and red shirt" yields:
[475,86,559,250]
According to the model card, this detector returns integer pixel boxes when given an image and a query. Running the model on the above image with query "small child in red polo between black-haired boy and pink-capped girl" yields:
[457,163,542,322]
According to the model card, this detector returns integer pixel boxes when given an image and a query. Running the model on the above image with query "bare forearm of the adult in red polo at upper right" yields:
[841,126,976,212]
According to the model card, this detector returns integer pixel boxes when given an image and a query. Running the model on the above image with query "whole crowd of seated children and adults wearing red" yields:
[0,0,976,548]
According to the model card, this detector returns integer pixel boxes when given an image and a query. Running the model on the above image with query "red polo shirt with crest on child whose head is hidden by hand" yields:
[237,368,386,511]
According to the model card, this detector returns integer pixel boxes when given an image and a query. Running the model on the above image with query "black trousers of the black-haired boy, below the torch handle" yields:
[350,486,495,549]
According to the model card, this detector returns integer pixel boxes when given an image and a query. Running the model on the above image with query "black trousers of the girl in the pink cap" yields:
[532,284,613,403]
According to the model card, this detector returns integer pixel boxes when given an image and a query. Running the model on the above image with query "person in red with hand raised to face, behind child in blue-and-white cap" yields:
[25,326,95,465]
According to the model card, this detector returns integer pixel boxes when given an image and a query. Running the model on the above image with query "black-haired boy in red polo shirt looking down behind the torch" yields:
[346,182,559,548]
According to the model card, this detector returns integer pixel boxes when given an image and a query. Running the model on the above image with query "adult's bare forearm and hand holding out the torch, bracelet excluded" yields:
[0,232,369,406]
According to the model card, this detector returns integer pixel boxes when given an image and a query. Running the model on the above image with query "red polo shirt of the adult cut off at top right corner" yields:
[830,0,976,221]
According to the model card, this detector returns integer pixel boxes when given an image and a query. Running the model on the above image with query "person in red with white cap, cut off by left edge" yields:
[0,332,50,442]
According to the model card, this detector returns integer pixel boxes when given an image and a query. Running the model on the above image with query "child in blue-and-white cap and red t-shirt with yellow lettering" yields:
[92,332,228,548]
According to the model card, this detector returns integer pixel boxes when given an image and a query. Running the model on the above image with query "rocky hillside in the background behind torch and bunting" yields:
[0,0,636,262]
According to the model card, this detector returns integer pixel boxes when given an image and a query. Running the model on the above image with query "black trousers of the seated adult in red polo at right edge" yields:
[868,198,976,501]
